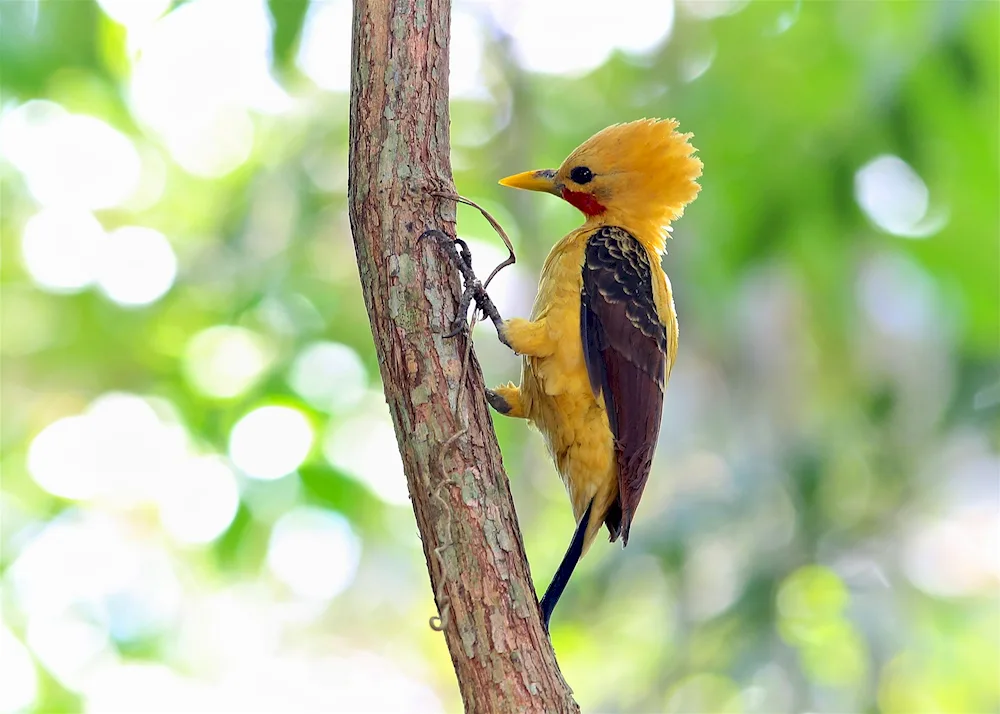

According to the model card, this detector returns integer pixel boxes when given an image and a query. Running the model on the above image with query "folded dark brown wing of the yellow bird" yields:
[580,226,667,544]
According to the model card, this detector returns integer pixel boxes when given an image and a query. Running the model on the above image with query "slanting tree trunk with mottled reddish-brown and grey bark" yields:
[349,0,578,712]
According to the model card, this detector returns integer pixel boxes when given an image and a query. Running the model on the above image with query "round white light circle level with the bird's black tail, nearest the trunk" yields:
[267,507,361,601]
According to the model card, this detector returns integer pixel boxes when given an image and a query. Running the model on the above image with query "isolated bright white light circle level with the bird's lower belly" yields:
[229,406,313,480]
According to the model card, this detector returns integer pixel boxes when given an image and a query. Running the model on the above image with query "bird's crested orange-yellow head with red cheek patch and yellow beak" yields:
[500,119,702,253]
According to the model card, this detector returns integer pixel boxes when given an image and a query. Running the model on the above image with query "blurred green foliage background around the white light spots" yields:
[0,0,1000,714]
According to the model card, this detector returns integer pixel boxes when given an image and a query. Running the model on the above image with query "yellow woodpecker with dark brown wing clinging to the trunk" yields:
[430,119,702,631]
